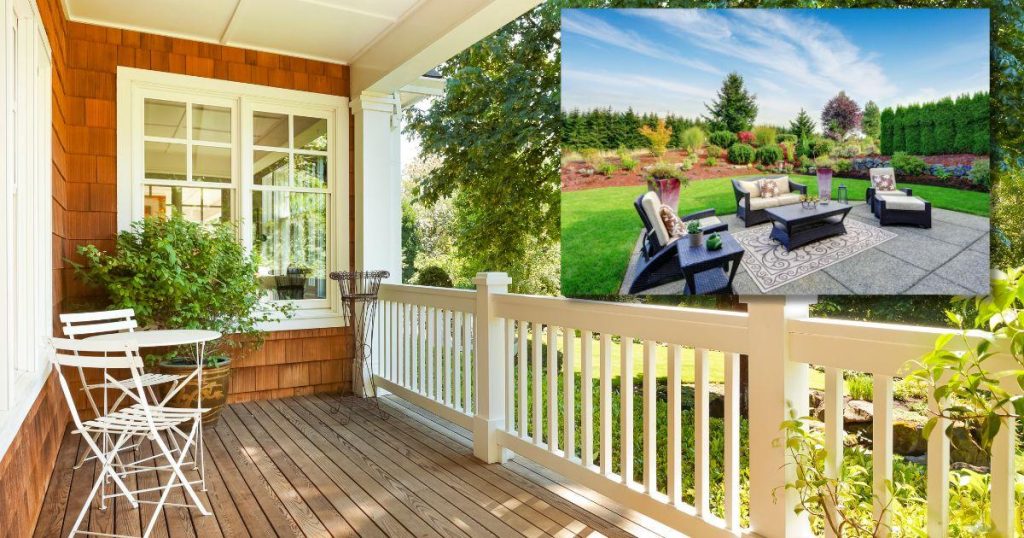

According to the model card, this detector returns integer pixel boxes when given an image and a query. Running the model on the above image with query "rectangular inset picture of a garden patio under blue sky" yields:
[561,9,991,296]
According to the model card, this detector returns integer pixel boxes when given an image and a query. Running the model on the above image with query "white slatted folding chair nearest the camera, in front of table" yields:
[50,338,210,538]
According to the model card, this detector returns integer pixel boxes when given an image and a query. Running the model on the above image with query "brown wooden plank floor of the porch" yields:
[36,396,674,538]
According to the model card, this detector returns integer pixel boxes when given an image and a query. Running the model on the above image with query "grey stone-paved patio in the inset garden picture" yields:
[620,202,990,295]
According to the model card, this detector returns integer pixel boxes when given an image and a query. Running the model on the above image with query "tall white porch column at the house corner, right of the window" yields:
[345,93,401,396]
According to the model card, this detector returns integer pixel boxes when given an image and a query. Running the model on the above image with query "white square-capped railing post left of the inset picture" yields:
[473,273,512,463]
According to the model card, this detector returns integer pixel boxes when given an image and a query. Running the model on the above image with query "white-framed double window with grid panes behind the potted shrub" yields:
[118,68,348,329]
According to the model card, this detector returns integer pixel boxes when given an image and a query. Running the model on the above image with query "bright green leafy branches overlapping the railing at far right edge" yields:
[908,267,1024,448]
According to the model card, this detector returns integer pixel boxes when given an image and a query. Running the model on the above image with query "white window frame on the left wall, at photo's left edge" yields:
[0,0,53,457]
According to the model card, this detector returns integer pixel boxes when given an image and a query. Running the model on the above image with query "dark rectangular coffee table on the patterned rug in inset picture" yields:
[765,202,850,251]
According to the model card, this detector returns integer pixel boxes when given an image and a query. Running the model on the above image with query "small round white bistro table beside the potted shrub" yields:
[85,329,221,491]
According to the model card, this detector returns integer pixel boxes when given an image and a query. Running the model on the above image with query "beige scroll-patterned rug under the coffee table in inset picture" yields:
[732,218,896,292]
